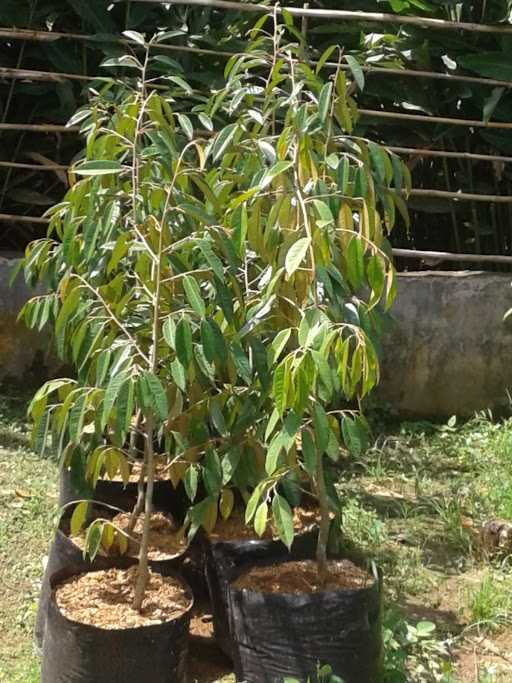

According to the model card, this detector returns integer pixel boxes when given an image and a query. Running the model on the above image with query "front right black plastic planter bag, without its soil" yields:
[228,563,383,683]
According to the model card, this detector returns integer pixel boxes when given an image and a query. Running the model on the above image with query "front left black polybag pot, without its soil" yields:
[41,559,193,683]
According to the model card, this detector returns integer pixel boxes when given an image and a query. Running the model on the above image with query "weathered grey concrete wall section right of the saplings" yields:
[378,271,512,417]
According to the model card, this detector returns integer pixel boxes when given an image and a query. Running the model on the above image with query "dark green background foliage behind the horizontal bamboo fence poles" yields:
[0,0,512,267]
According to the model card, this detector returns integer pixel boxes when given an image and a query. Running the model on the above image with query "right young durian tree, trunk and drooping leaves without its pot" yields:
[200,11,410,580]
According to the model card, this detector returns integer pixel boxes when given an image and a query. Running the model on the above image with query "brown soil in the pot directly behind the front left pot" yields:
[71,510,187,560]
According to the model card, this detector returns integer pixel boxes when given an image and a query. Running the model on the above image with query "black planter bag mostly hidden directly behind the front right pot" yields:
[205,529,318,659]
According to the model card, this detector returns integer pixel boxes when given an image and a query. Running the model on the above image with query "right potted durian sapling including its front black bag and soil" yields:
[195,12,410,683]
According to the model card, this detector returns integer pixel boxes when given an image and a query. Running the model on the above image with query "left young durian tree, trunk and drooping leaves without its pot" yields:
[22,31,276,609]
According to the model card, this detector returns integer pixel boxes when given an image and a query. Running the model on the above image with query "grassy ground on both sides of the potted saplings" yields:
[0,387,512,683]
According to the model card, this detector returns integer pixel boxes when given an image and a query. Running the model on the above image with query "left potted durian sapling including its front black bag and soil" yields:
[19,32,243,683]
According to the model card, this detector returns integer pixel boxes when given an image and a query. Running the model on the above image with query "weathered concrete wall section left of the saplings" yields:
[0,254,57,383]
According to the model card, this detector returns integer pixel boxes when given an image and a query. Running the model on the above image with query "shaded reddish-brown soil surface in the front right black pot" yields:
[233,560,375,595]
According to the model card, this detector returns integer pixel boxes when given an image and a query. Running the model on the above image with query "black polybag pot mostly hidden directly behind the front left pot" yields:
[34,510,206,649]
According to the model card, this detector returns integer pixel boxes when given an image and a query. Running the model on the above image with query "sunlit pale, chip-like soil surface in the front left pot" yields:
[55,565,191,629]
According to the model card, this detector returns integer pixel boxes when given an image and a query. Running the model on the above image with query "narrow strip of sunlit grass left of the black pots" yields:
[0,387,56,683]
